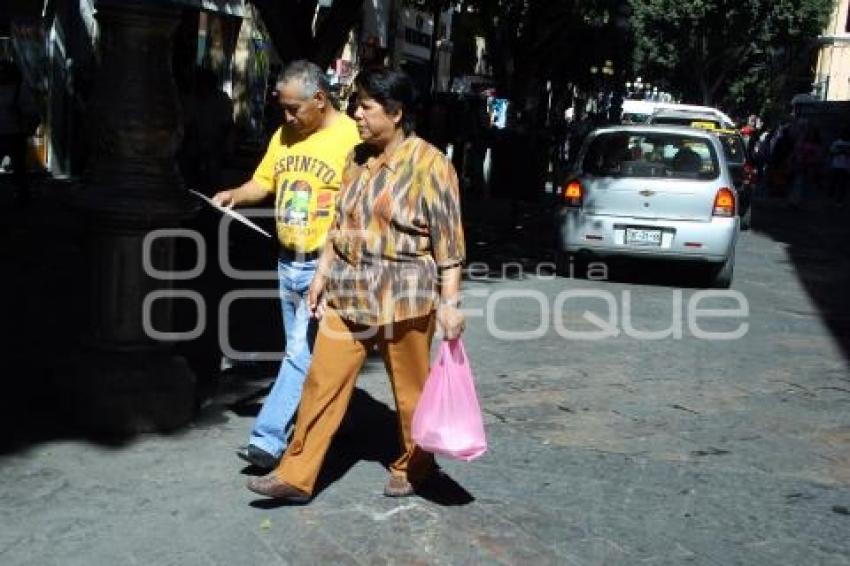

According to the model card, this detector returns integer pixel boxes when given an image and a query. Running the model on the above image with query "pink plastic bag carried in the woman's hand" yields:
[412,339,487,462]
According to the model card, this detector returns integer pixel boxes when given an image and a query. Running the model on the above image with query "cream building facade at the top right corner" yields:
[813,0,850,100]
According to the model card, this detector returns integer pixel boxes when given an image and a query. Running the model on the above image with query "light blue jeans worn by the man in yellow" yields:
[248,259,318,457]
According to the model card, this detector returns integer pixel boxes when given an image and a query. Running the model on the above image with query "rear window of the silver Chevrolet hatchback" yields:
[582,132,720,180]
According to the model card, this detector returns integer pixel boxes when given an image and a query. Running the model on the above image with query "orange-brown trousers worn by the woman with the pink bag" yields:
[275,309,435,494]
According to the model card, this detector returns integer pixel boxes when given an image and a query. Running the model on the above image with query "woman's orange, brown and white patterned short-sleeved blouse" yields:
[326,136,466,326]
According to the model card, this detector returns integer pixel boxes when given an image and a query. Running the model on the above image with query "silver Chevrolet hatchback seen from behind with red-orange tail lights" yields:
[556,126,739,288]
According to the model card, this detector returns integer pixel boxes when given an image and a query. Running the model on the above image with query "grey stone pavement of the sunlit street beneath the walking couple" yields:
[0,187,850,566]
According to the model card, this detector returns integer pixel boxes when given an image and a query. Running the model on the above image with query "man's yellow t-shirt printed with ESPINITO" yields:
[254,114,360,252]
